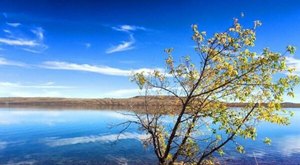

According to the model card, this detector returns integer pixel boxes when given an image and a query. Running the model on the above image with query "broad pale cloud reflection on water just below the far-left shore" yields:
[0,109,135,126]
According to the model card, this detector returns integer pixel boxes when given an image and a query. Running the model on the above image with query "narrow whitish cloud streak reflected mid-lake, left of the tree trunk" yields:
[42,132,148,147]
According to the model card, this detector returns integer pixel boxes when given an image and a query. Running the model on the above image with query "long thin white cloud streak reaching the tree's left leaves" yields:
[40,61,163,76]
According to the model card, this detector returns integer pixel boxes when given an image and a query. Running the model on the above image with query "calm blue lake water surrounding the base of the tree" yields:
[0,109,300,164]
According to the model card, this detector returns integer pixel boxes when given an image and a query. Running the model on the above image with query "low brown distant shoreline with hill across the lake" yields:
[0,96,300,110]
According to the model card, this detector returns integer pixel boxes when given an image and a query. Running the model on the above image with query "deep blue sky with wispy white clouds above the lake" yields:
[0,0,300,102]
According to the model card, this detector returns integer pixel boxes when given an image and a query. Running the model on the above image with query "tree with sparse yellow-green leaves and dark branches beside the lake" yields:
[128,19,299,164]
